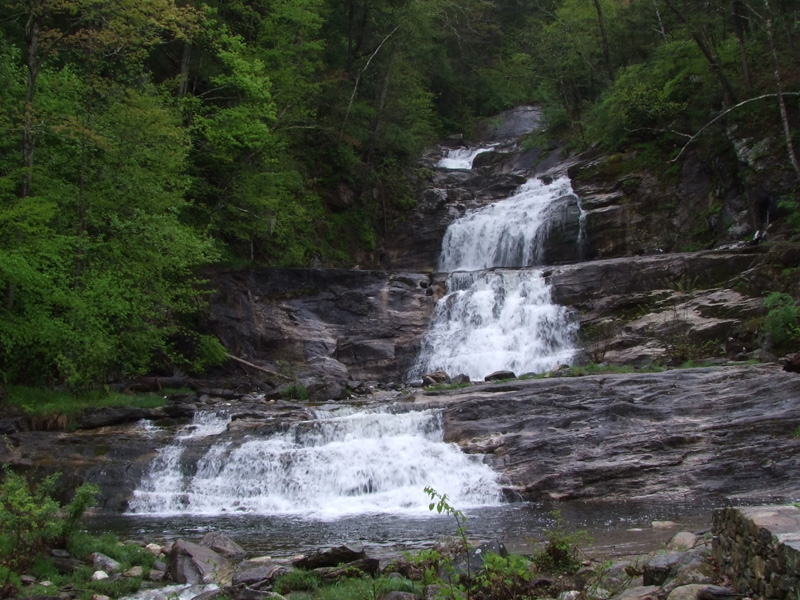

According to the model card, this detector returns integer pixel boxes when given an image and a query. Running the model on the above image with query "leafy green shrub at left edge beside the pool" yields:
[0,467,99,570]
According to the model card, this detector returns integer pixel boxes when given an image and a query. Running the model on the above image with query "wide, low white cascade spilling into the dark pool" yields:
[129,409,500,519]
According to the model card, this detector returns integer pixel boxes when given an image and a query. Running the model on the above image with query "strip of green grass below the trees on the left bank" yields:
[4,385,167,416]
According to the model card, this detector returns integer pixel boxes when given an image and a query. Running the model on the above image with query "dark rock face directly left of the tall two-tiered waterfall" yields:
[207,269,434,384]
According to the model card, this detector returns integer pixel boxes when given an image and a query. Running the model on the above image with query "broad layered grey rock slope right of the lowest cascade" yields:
[434,365,800,501]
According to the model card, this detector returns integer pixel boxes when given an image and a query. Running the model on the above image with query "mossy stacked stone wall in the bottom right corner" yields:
[713,505,800,600]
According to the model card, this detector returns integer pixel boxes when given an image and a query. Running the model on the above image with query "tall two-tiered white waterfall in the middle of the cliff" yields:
[409,177,576,379]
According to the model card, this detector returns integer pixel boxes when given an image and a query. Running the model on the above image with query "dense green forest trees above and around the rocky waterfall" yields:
[0,0,800,387]
